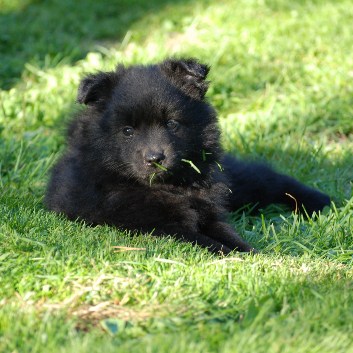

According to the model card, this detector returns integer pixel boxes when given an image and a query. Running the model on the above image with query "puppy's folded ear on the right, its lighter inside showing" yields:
[160,59,210,99]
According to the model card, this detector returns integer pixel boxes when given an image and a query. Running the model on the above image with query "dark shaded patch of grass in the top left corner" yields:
[0,0,200,89]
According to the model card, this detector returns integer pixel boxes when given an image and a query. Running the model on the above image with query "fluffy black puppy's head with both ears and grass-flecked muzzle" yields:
[77,59,220,183]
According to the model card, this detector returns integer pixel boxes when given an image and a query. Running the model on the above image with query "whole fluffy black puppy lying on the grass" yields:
[45,59,329,253]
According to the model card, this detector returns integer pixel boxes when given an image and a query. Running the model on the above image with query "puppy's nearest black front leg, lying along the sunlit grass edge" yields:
[97,188,233,254]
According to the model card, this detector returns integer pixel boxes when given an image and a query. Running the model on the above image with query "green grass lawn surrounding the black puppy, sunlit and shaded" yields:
[0,0,353,353]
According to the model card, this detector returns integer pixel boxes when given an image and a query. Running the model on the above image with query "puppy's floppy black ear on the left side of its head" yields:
[77,67,122,106]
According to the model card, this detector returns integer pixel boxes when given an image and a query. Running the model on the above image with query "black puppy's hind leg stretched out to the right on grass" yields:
[223,156,330,214]
